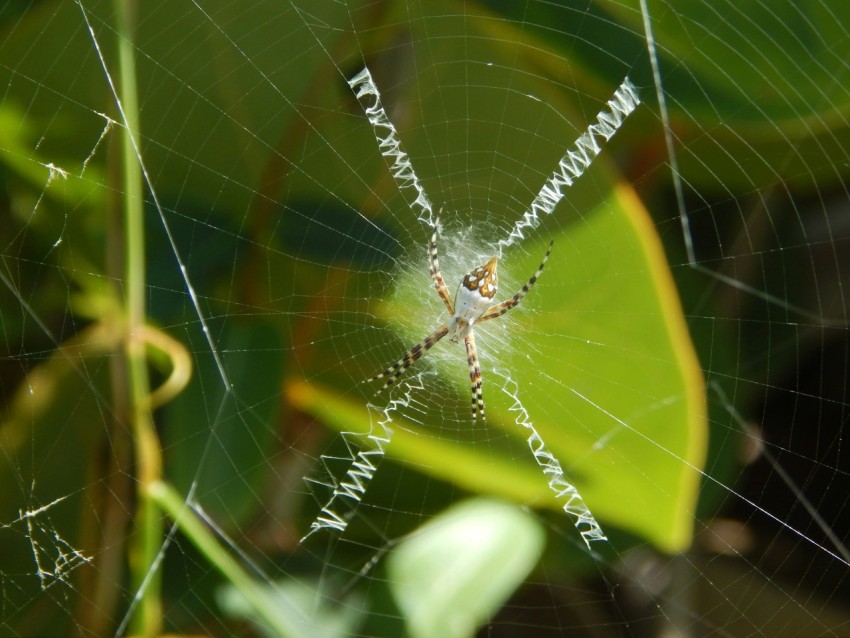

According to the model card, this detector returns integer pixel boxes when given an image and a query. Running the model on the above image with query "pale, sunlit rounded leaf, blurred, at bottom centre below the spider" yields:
[387,499,545,638]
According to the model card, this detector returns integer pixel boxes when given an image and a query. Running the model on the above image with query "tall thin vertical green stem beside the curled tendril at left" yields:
[114,0,162,637]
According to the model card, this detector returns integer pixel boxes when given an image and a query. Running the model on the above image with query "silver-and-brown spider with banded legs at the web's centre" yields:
[364,211,554,421]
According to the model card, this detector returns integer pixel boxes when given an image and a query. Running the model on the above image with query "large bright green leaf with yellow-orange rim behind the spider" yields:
[289,176,707,551]
